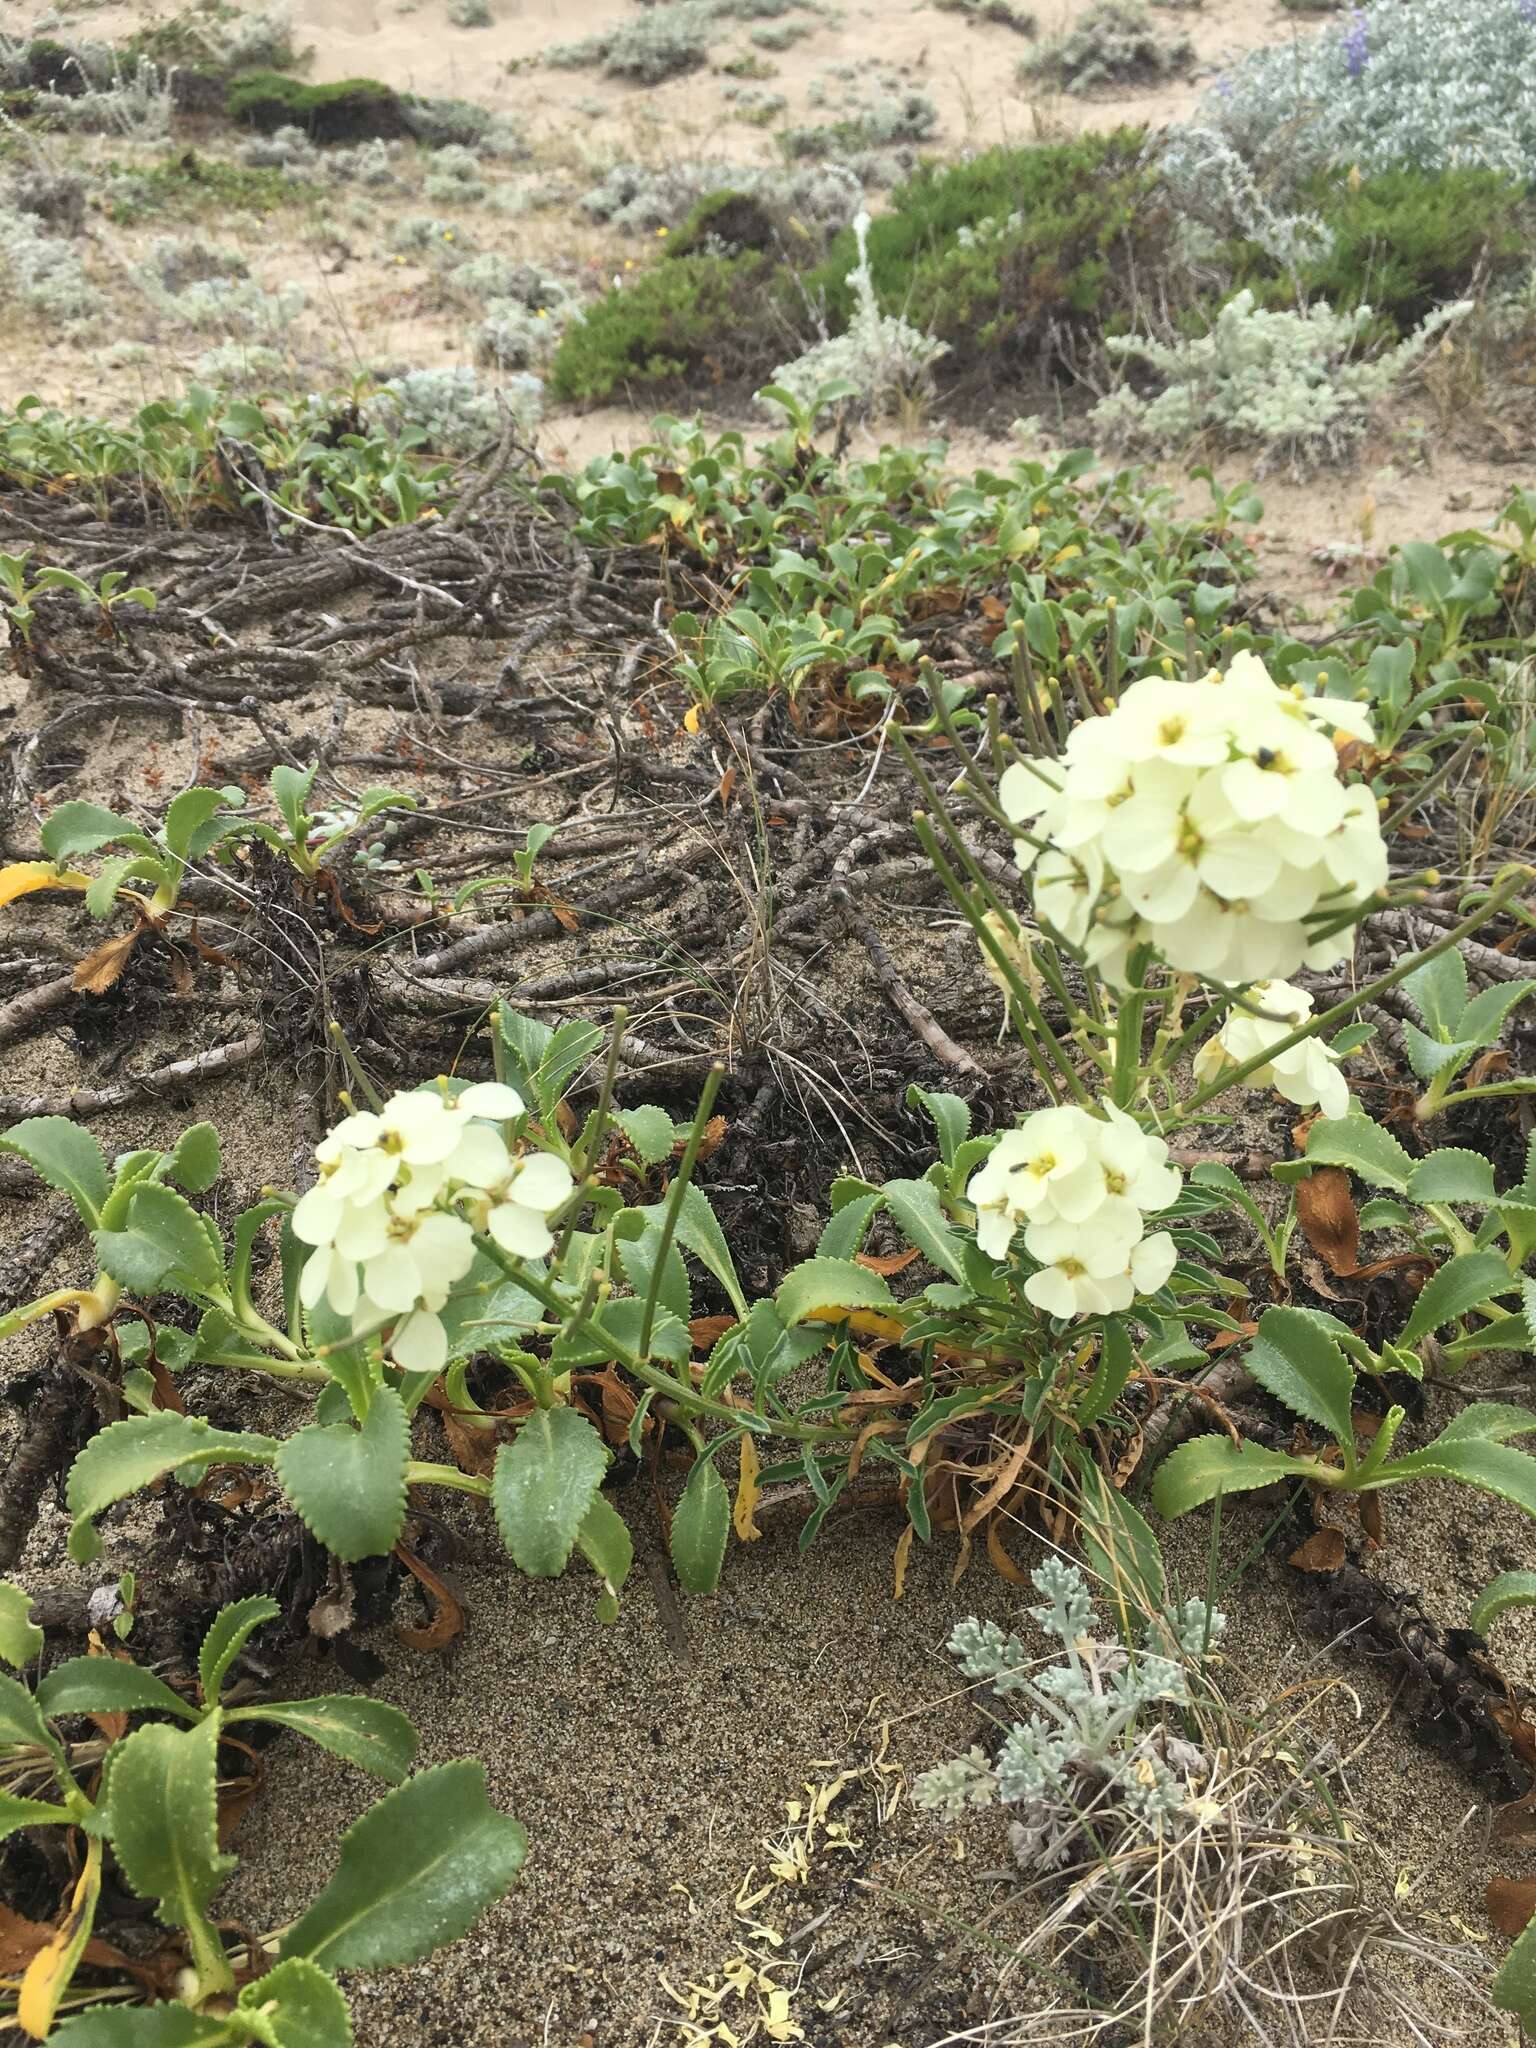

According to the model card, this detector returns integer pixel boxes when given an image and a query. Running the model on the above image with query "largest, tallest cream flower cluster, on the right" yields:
[999,653,1386,987]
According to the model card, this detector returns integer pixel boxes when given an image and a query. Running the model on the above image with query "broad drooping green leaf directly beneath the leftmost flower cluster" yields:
[274,1386,410,1565]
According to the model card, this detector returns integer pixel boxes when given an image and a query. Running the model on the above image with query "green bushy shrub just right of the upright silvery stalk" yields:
[807,129,1171,371]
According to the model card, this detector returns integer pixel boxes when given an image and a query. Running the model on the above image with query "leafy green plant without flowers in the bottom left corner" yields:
[0,1581,526,2048]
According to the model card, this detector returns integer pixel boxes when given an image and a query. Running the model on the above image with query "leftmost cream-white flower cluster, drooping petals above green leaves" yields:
[293,1081,575,1372]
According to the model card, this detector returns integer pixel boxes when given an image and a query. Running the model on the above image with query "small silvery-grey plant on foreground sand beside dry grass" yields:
[913,1559,1227,1870]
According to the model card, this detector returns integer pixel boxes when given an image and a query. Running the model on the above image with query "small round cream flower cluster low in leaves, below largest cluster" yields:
[965,1102,1184,1317]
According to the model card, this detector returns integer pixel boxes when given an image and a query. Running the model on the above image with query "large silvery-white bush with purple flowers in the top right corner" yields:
[1202,0,1536,182]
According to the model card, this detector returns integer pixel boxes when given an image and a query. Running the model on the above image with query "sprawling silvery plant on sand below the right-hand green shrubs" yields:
[1090,291,1473,473]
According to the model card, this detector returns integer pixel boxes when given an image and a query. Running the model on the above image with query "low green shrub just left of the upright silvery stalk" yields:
[549,254,788,401]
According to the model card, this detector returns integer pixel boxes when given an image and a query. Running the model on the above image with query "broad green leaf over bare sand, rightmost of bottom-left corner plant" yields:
[283,1761,528,1970]
